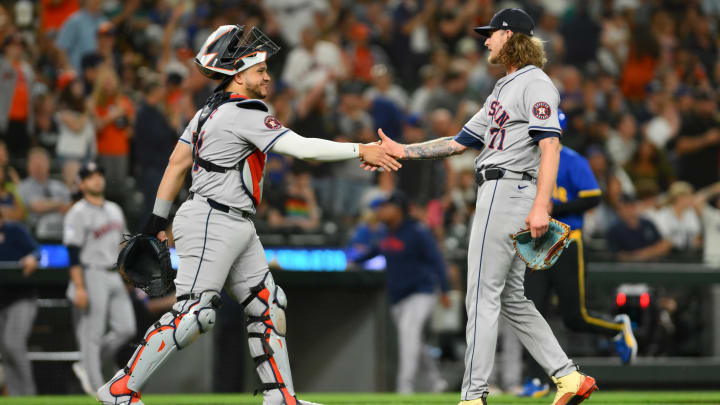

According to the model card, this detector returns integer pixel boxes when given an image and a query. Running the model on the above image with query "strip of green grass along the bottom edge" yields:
[0,391,720,405]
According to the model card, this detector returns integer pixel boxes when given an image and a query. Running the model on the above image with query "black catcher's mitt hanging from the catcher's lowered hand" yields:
[116,234,175,297]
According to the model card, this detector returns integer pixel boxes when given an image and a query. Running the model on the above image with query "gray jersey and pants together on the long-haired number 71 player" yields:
[455,65,575,400]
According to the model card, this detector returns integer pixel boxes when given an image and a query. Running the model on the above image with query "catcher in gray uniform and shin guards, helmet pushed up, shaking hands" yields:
[98,25,400,405]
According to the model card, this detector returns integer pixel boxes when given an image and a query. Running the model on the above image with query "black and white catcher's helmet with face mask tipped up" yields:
[195,25,280,80]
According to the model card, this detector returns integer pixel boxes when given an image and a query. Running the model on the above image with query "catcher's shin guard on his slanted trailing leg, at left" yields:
[125,290,220,392]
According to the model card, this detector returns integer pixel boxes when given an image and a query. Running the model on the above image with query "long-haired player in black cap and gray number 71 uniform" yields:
[380,9,597,405]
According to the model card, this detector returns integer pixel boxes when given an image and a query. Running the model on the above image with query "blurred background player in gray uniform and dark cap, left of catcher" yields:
[63,163,135,395]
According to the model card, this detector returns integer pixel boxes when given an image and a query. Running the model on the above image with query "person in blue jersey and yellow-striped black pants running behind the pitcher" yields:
[522,143,637,397]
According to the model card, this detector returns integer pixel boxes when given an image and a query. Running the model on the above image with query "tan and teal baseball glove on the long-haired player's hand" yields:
[510,219,571,270]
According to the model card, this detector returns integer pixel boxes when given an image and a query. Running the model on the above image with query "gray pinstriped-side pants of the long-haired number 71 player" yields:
[461,179,576,400]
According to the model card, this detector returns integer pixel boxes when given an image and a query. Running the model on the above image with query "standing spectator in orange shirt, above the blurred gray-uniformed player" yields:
[90,66,135,201]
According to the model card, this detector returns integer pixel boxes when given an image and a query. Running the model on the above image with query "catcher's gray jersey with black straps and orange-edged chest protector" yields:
[180,99,290,212]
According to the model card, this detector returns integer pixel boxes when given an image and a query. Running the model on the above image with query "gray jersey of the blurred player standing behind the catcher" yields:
[63,199,126,269]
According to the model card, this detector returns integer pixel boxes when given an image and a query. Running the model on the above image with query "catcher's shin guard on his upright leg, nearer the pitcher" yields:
[243,273,299,405]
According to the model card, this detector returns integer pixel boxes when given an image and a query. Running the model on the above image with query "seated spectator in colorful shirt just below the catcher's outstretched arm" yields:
[268,167,320,231]
